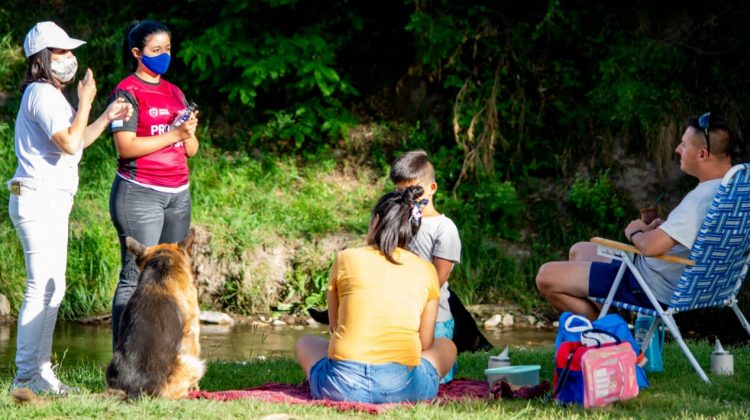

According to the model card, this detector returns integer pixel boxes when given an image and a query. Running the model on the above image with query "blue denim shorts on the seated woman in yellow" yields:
[310,357,439,404]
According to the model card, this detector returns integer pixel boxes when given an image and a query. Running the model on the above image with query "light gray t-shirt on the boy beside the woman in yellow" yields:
[408,214,461,322]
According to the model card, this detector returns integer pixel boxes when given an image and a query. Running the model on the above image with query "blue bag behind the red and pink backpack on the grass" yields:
[555,312,649,388]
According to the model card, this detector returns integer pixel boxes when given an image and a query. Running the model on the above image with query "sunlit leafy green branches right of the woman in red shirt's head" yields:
[179,0,358,152]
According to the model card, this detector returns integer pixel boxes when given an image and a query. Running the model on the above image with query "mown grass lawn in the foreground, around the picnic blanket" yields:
[0,343,750,419]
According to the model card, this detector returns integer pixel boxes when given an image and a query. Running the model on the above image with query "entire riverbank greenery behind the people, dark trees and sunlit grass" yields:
[0,0,750,318]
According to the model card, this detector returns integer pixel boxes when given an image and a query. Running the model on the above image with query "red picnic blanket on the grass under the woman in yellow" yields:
[188,379,489,414]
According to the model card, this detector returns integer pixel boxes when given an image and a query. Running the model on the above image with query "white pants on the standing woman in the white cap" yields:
[8,187,73,383]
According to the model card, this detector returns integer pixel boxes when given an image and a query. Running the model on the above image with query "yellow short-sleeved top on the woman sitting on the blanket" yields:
[328,247,440,366]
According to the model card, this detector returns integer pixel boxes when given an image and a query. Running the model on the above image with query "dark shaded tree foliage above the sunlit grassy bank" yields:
[0,0,750,244]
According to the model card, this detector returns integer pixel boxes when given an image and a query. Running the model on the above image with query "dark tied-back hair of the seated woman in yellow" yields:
[367,185,426,264]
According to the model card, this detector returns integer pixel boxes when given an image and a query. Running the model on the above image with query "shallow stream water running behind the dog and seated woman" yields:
[0,322,555,375]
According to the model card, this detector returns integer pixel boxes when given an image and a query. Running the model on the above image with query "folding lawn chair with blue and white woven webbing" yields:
[592,163,750,382]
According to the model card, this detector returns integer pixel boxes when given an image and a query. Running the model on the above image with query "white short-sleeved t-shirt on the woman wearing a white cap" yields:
[11,82,83,194]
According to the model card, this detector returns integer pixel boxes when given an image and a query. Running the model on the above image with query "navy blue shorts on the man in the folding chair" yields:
[589,261,668,309]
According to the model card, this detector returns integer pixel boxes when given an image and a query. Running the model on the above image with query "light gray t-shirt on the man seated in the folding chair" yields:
[635,178,721,303]
